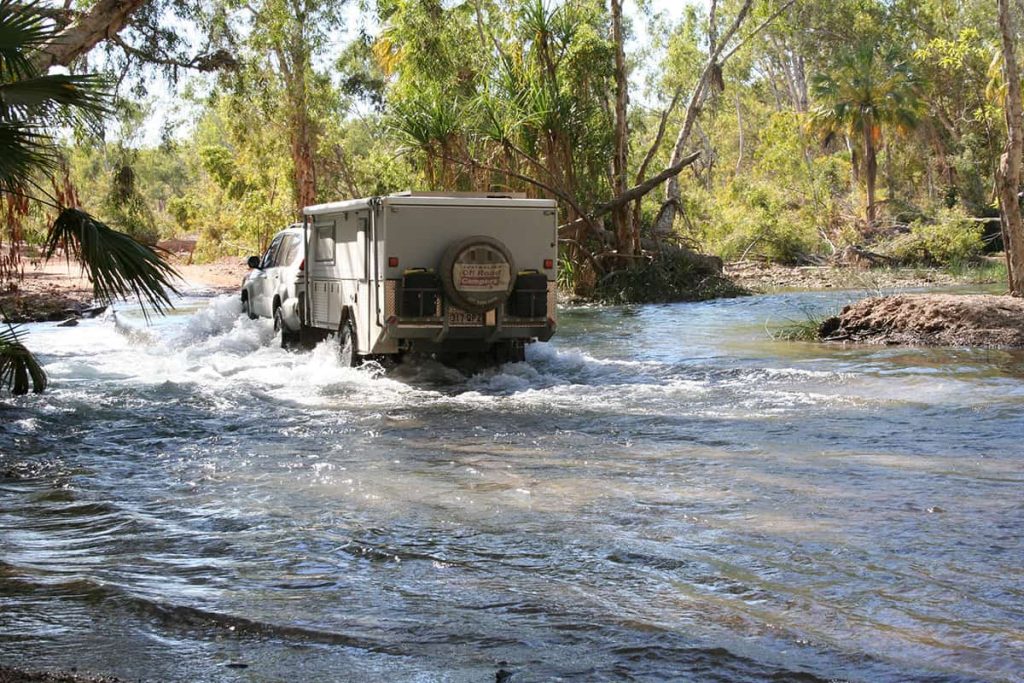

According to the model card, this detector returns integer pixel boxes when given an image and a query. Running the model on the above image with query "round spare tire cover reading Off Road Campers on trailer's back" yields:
[439,234,515,313]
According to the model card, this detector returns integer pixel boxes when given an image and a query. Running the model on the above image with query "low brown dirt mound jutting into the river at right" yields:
[818,294,1024,348]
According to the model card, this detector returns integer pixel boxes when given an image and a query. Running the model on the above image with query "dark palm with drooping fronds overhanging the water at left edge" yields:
[0,0,177,394]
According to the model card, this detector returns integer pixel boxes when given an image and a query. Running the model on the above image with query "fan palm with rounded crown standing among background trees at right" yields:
[811,43,922,228]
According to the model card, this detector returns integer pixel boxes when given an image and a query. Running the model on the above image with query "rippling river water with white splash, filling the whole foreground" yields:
[0,293,1024,682]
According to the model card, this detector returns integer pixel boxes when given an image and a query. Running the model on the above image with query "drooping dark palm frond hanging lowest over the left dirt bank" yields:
[45,209,180,316]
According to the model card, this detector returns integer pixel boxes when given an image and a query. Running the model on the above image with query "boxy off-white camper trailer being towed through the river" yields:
[302,196,558,355]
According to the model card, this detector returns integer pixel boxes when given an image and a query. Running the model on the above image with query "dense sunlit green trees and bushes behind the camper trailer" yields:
[4,0,1019,290]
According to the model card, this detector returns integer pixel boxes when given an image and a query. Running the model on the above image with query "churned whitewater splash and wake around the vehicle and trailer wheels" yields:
[22,295,872,414]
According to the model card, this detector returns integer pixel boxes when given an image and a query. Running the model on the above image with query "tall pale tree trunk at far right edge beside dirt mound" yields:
[995,0,1024,296]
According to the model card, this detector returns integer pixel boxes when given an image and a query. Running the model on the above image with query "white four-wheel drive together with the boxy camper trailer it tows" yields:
[242,193,558,365]
